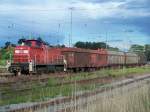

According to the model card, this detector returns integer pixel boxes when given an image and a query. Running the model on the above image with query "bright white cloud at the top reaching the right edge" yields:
[71,0,150,19]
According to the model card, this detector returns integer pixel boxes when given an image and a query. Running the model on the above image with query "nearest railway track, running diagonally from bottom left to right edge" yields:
[1,74,150,112]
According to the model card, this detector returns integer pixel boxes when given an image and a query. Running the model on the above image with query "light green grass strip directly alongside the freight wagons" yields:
[63,66,150,81]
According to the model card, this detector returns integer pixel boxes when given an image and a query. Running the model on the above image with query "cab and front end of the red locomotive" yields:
[9,40,43,74]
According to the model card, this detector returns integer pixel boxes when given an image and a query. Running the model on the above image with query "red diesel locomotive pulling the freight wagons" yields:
[9,40,64,73]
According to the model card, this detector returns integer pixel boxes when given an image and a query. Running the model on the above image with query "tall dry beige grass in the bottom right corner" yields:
[76,82,150,112]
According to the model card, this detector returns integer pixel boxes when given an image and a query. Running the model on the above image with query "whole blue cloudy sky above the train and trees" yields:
[0,0,150,49]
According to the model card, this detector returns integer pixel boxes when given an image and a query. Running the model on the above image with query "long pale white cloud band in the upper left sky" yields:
[0,2,70,22]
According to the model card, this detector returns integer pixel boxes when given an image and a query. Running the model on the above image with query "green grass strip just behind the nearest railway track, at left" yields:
[0,84,94,105]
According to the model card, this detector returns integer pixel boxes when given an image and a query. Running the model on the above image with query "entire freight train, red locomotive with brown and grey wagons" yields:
[9,40,146,74]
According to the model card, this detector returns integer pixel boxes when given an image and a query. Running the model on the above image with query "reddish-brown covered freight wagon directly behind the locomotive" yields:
[62,48,107,69]
